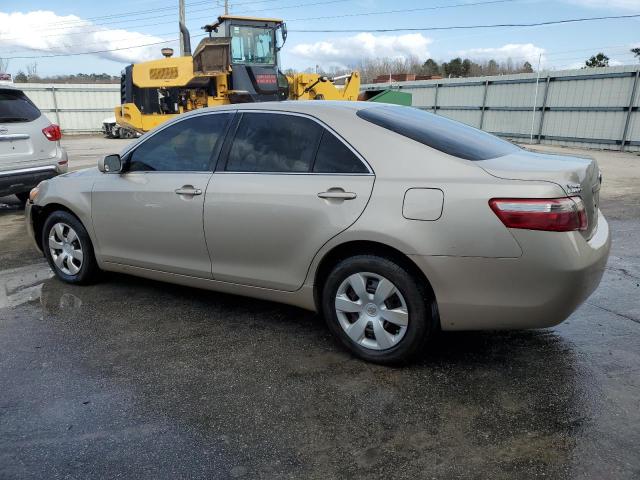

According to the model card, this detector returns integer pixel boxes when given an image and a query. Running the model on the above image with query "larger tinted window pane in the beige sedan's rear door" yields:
[226,112,322,173]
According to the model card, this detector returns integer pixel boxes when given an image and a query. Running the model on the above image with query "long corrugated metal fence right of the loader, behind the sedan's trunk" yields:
[362,66,640,151]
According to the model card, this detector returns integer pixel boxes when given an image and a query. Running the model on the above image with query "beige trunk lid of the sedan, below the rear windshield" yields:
[474,150,601,238]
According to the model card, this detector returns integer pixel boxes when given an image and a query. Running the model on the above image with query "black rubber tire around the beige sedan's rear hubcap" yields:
[321,255,439,365]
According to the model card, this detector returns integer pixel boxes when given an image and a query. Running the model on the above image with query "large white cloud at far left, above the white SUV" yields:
[0,10,171,62]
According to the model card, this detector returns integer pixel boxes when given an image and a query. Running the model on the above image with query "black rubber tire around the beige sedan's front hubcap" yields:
[42,210,100,285]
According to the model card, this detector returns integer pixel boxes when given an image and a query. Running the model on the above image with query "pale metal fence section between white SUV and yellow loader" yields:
[14,83,120,133]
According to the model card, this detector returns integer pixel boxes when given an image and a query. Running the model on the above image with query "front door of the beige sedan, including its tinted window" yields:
[92,113,233,278]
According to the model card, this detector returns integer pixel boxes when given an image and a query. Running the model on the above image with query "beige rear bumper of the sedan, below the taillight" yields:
[412,212,611,330]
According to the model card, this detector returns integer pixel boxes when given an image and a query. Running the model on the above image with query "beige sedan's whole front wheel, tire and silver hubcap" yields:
[42,211,99,284]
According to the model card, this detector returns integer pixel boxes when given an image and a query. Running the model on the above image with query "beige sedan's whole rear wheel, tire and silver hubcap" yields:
[322,255,438,364]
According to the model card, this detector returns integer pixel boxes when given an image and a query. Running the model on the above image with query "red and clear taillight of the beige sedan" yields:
[489,197,587,232]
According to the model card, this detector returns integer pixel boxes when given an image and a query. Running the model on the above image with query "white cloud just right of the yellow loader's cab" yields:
[290,33,432,68]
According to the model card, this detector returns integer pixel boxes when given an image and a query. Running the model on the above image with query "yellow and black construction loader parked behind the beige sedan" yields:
[115,15,360,132]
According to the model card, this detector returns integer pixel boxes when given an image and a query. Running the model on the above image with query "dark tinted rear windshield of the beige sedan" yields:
[357,105,519,160]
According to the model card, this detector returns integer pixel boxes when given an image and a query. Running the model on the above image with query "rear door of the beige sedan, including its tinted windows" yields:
[204,111,374,291]
